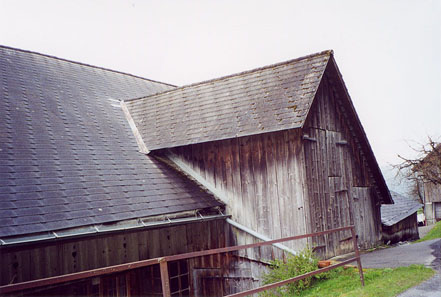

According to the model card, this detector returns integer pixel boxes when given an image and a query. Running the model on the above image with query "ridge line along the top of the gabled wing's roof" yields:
[125,50,334,101]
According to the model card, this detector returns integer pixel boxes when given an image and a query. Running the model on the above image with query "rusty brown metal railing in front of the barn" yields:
[0,226,364,297]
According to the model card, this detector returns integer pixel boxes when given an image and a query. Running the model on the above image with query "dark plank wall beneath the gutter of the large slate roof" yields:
[0,220,257,296]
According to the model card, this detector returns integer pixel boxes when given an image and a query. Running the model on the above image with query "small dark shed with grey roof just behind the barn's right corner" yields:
[381,191,423,243]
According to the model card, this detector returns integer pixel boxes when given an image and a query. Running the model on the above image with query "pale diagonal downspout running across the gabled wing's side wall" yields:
[166,150,297,255]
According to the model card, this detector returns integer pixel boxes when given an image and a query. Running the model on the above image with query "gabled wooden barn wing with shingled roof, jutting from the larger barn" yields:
[125,51,391,257]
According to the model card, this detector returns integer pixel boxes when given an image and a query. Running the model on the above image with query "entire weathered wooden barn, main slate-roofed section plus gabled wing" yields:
[0,47,392,296]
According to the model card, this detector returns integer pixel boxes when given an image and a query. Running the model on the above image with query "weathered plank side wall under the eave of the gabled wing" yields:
[168,130,309,253]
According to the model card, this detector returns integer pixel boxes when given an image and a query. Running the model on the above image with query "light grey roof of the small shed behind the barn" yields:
[381,191,423,226]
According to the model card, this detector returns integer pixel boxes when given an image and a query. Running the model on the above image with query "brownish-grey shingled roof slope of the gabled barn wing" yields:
[127,51,332,150]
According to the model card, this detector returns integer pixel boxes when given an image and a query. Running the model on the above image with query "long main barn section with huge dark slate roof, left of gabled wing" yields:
[0,47,234,296]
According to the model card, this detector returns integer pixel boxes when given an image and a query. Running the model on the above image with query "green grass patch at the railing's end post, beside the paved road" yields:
[262,265,435,297]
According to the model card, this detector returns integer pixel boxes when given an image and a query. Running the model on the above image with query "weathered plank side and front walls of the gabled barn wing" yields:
[163,66,381,259]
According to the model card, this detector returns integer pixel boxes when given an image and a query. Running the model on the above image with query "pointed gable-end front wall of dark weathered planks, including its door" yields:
[303,74,381,257]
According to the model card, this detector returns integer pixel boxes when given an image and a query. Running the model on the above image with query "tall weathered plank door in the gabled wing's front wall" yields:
[304,129,352,257]
